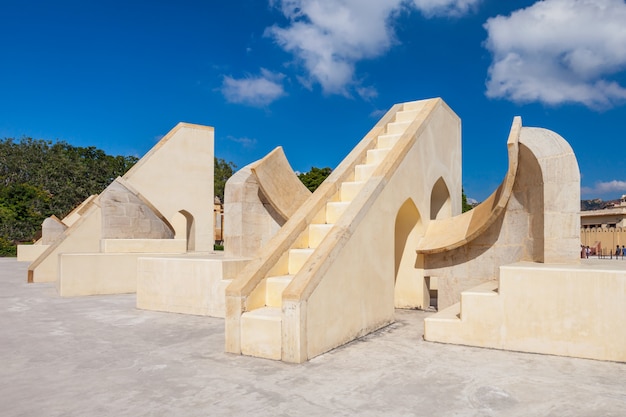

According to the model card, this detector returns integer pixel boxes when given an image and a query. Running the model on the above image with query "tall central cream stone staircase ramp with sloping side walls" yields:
[226,99,461,362]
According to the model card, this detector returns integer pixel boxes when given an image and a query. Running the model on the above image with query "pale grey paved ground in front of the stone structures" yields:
[0,258,626,417]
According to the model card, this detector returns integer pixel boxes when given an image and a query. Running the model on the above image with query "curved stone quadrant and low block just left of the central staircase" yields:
[137,147,311,317]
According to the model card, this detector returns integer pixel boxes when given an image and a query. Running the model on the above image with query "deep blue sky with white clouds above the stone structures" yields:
[0,0,626,201]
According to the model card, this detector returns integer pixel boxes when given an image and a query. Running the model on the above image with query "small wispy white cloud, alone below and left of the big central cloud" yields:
[221,69,285,107]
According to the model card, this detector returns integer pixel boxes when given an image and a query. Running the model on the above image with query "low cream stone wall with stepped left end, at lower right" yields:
[424,263,626,362]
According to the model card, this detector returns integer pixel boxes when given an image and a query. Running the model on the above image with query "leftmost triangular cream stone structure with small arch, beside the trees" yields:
[18,123,213,296]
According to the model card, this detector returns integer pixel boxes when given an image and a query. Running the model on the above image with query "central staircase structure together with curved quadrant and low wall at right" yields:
[225,99,626,363]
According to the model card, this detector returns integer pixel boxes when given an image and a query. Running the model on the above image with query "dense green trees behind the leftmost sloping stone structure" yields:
[0,138,137,255]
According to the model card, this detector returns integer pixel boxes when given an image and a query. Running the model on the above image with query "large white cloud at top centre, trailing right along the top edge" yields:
[266,0,482,96]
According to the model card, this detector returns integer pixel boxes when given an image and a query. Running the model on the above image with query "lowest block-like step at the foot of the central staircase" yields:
[241,307,282,360]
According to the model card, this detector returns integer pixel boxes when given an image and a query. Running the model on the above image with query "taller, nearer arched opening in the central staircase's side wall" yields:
[394,199,430,309]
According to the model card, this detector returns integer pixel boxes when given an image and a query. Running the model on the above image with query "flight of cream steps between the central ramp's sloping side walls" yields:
[236,103,421,360]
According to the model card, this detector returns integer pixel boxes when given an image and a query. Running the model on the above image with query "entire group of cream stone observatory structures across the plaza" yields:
[18,99,626,363]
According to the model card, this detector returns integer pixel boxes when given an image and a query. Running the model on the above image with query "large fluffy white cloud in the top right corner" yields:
[485,0,626,108]
